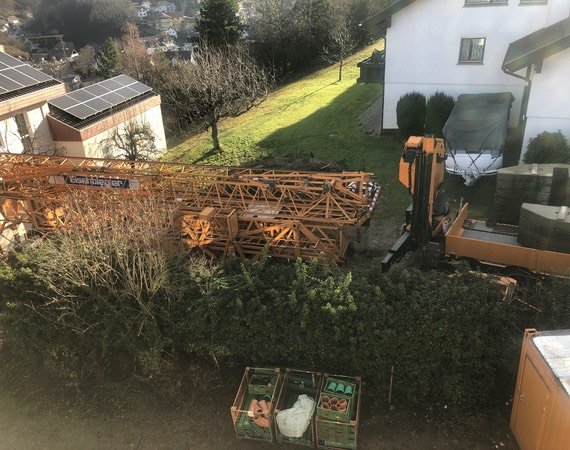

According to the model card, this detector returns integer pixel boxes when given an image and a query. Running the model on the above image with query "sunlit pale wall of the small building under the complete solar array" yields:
[56,105,166,158]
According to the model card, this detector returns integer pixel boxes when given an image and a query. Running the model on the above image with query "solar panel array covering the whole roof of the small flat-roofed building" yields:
[49,75,151,120]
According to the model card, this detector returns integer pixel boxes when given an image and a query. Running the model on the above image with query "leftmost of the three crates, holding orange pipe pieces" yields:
[230,367,282,442]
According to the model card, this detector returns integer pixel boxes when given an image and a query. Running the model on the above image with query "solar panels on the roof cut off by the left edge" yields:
[0,52,61,102]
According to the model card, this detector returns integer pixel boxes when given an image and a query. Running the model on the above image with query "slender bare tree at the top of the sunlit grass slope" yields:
[323,0,357,81]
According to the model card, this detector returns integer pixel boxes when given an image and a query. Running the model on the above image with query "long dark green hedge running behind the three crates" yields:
[5,243,570,409]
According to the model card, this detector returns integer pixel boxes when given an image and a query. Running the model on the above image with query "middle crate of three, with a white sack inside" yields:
[273,369,322,447]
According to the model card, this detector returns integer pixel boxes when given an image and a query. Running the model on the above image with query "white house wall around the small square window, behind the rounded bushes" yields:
[383,0,570,129]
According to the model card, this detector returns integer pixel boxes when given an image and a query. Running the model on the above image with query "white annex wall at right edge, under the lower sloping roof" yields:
[521,48,570,160]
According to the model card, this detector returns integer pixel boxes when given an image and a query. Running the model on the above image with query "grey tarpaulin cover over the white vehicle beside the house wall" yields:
[443,92,514,153]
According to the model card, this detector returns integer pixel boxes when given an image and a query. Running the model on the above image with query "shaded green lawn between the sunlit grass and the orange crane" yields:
[254,84,409,217]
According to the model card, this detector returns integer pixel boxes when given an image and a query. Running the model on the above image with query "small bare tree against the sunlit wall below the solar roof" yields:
[102,119,159,161]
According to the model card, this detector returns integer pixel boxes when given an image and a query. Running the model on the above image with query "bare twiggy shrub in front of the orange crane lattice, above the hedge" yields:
[18,189,189,381]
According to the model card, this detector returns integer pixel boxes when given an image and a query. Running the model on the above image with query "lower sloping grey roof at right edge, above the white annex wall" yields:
[503,17,570,73]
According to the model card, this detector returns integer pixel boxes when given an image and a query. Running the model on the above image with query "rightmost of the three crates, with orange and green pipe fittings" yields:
[315,374,362,450]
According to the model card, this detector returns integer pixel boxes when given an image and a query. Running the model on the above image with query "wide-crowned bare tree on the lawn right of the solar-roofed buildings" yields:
[161,46,272,151]
